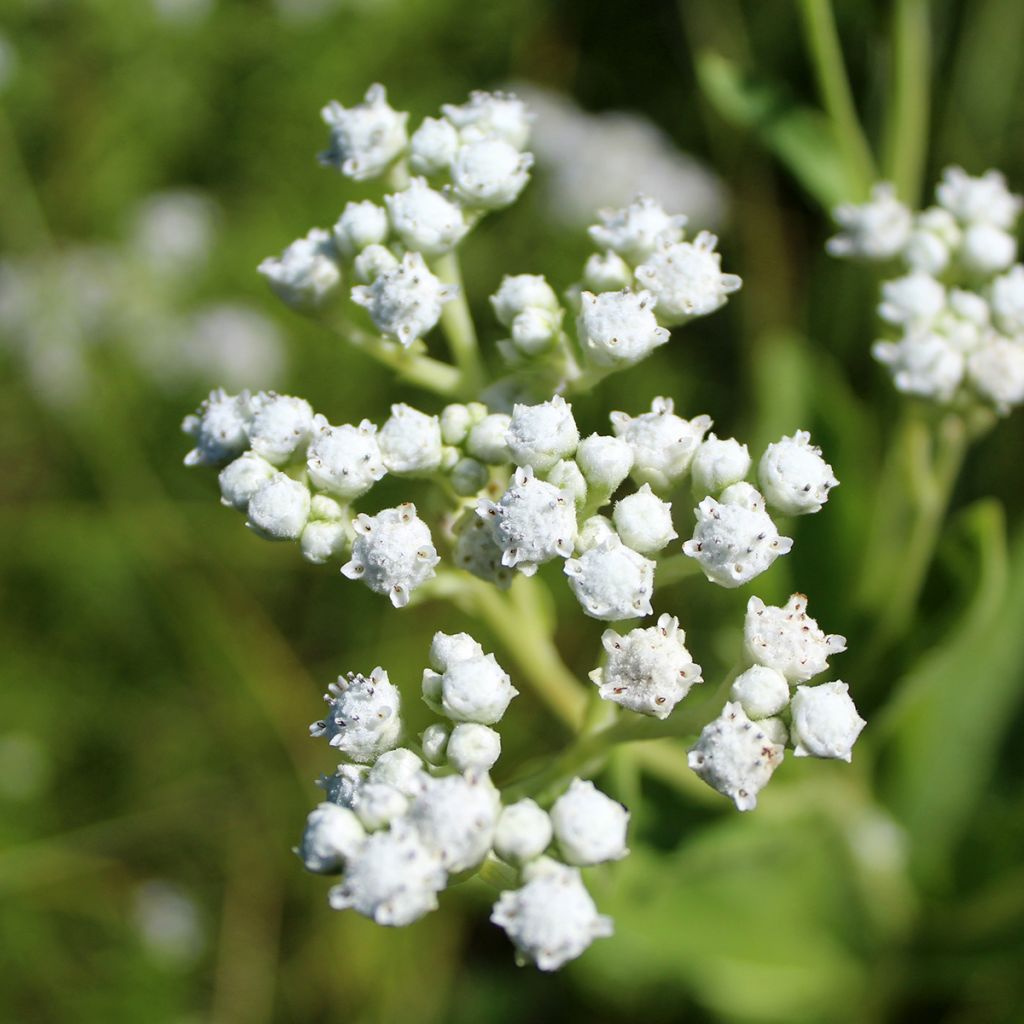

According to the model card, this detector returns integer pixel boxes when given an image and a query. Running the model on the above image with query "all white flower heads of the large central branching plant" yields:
[184,85,864,970]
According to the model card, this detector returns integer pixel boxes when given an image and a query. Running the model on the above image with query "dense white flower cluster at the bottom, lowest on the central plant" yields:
[296,633,629,971]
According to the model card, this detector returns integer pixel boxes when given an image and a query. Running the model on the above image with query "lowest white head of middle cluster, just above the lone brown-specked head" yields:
[565,537,655,623]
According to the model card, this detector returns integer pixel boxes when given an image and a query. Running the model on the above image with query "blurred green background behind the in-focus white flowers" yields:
[0,0,1024,1024]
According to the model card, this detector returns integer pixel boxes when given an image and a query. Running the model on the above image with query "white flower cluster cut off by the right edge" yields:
[827,167,1024,414]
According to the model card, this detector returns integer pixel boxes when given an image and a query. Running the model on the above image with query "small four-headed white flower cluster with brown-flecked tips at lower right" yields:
[689,594,865,811]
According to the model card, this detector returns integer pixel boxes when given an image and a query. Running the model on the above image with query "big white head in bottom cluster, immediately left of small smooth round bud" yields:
[409,774,501,872]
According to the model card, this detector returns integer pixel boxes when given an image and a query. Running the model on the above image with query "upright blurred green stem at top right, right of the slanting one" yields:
[883,0,931,207]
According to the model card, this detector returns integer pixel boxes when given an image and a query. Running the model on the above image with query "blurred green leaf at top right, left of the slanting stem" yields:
[696,50,851,211]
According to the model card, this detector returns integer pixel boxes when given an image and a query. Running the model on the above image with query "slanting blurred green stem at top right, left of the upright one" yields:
[799,0,876,200]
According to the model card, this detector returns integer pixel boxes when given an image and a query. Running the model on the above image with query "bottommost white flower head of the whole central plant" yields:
[490,857,611,971]
